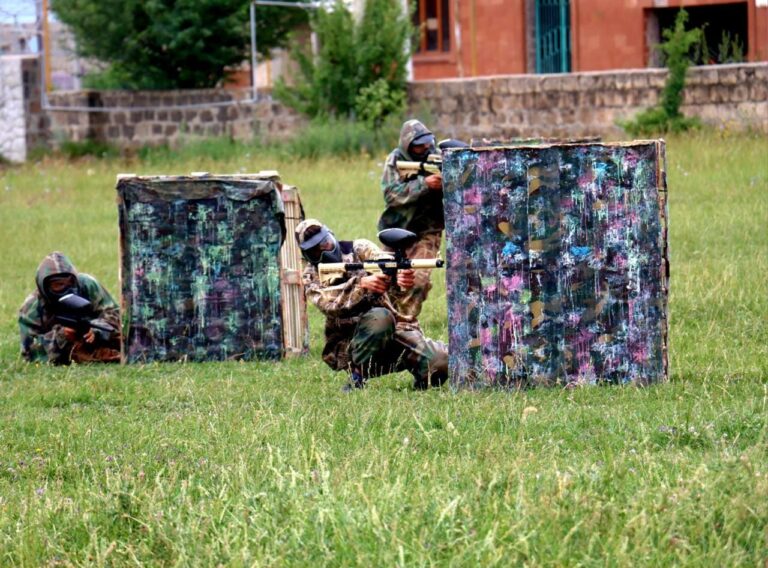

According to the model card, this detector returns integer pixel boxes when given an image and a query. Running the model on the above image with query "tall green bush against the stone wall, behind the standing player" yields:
[275,0,414,125]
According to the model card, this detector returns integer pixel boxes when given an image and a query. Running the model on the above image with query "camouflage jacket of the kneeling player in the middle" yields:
[303,239,419,371]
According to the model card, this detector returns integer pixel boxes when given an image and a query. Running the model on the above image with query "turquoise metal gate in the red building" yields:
[536,0,571,73]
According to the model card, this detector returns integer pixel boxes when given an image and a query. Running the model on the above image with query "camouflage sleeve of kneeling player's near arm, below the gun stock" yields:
[303,265,370,317]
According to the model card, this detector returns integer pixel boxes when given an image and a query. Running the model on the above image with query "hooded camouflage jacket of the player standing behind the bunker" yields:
[379,120,445,236]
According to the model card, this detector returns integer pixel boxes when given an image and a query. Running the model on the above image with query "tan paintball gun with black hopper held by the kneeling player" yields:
[317,228,445,284]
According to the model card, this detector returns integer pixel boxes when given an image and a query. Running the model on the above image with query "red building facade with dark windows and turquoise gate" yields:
[413,0,768,80]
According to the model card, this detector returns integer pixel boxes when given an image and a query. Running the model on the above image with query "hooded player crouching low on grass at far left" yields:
[19,252,120,365]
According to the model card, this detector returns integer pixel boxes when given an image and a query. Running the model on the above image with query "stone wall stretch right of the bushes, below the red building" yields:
[409,63,768,139]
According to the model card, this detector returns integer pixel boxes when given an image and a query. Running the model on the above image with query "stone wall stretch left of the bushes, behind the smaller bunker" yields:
[49,89,305,148]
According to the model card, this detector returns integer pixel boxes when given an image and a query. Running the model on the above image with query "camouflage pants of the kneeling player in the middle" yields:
[349,308,448,389]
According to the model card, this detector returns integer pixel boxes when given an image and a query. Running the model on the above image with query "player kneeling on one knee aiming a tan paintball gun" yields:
[296,219,448,391]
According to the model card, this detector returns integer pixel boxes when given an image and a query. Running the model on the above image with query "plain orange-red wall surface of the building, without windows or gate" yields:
[413,0,768,80]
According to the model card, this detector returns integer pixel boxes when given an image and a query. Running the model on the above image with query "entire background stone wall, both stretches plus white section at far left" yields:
[0,56,768,161]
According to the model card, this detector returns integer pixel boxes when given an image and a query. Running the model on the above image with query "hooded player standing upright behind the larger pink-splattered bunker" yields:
[379,119,445,317]
